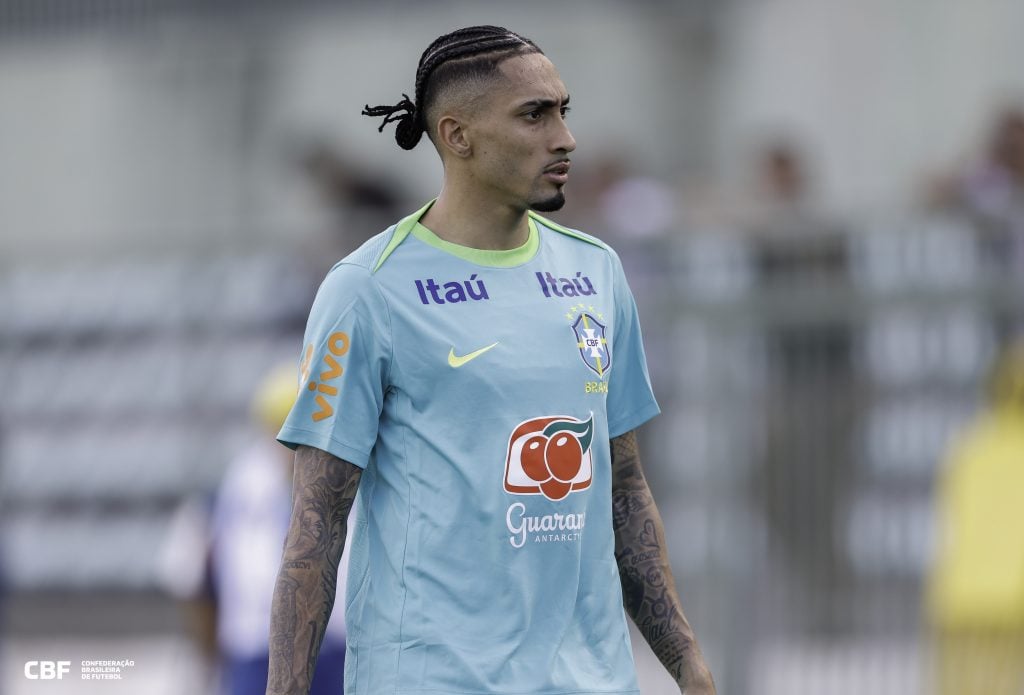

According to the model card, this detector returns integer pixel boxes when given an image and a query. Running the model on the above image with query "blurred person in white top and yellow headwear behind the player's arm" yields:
[162,364,348,695]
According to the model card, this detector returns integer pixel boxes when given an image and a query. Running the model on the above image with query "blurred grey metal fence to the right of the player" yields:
[624,215,1024,694]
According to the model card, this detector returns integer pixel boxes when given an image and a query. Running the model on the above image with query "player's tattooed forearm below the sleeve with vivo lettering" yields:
[266,446,362,695]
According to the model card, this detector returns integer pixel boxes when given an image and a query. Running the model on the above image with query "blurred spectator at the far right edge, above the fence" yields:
[930,106,1024,271]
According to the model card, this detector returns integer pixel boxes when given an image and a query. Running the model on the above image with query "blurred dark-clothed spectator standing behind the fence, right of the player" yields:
[741,139,856,633]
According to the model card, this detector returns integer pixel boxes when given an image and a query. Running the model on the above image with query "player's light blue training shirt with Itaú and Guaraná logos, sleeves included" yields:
[279,204,658,695]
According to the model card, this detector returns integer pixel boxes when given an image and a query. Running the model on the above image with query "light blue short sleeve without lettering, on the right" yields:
[607,252,660,438]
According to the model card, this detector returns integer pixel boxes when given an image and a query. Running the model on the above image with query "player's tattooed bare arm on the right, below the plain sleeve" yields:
[611,432,715,695]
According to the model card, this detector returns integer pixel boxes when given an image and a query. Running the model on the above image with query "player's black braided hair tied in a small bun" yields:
[362,26,544,149]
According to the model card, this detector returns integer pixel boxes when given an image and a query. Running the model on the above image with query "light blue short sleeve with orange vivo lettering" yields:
[278,263,391,468]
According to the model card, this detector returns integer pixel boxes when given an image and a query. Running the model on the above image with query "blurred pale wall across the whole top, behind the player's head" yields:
[6,0,1024,257]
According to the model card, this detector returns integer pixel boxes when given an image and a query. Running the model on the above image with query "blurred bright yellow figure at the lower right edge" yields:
[927,341,1024,695]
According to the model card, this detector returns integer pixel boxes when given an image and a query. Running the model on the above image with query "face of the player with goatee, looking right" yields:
[468,53,575,212]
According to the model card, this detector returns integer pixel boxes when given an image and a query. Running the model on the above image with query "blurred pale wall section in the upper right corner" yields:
[715,0,1024,213]
